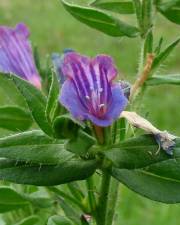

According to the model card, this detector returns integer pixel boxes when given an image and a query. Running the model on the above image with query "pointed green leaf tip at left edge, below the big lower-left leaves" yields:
[0,187,29,213]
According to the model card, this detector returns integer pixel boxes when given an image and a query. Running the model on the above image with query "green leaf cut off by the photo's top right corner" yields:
[157,0,180,24]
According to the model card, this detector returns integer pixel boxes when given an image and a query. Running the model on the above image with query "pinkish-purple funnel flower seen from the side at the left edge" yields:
[0,23,41,88]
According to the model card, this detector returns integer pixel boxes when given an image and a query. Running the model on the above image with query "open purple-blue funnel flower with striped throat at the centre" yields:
[60,52,128,127]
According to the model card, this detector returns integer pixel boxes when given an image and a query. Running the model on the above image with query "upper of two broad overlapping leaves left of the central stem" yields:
[0,130,73,164]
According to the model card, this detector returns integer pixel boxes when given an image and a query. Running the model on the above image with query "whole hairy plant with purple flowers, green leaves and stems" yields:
[0,0,180,225]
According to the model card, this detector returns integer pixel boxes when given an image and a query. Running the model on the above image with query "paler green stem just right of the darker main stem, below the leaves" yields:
[106,178,119,225]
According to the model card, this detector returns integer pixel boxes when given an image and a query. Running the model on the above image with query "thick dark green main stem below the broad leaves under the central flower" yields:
[96,171,111,225]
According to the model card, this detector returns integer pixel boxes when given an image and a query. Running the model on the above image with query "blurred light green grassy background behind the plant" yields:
[0,0,180,225]
